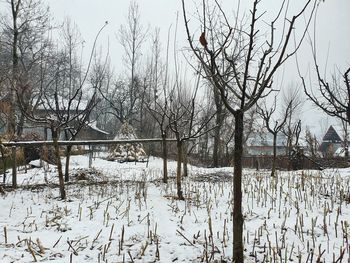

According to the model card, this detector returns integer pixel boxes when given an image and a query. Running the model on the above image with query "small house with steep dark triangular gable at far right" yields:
[319,125,343,157]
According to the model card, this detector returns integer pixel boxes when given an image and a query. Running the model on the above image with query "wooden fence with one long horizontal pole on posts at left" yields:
[2,138,176,188]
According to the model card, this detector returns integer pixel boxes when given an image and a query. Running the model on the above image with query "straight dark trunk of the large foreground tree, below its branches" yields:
[232,111,244,263]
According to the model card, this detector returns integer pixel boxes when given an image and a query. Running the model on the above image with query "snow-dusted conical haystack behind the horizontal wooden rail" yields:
[107,122,147,162]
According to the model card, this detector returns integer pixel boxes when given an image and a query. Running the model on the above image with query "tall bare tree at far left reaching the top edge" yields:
[1,0,49,135]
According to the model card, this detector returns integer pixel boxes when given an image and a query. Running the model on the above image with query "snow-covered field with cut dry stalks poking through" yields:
[0,156,350,262]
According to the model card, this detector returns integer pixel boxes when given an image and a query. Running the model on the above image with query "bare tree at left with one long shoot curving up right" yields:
[15,23,107,199]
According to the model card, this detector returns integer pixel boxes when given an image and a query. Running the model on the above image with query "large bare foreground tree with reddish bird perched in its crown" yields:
[182,0,315,262]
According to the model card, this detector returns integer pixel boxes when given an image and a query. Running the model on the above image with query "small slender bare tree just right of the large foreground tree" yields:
[257,95,291,177]
